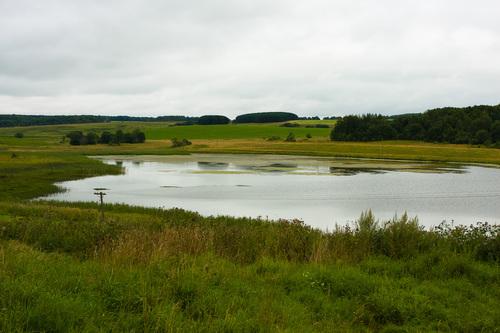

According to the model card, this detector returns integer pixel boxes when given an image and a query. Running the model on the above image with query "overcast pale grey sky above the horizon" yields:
[0,0,500,117]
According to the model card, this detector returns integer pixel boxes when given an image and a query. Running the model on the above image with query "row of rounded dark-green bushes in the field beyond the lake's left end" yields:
[66,129,146,146]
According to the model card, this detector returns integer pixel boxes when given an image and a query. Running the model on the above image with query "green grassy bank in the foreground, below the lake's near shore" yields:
[0,203,500,332]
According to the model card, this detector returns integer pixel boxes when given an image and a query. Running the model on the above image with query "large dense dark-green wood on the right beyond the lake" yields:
[330,105,500,145]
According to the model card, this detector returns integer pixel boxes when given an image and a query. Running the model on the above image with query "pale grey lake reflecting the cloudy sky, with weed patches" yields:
[41,154,500,230]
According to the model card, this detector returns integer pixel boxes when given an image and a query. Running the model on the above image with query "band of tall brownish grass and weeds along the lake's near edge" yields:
[0,203,500,263]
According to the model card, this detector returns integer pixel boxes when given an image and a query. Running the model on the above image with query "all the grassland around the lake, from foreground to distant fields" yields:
[0,123,500,332]
